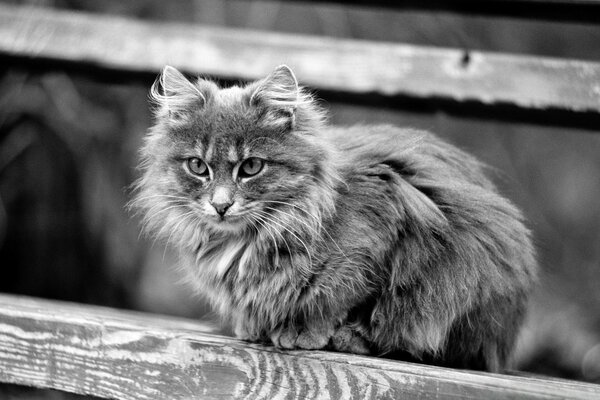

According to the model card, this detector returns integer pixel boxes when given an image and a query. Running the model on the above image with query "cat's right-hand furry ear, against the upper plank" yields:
[249,65,302,127]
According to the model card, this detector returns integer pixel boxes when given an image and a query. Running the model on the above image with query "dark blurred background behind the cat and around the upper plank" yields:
[0,0,600,390]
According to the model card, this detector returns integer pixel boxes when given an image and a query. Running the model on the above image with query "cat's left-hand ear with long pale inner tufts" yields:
[150,65,206,120]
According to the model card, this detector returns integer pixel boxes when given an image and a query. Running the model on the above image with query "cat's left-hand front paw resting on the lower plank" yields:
[271,320,335,350]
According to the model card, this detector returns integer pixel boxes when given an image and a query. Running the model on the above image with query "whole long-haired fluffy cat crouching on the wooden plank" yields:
[133,65,537,372]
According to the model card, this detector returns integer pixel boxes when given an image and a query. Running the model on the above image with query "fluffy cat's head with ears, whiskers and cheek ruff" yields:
[134,66,333,245]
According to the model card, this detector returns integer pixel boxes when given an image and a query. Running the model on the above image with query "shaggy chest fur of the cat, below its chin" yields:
[187,233,307,335]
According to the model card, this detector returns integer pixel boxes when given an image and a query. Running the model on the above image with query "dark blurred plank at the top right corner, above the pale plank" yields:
[251,0,600,24]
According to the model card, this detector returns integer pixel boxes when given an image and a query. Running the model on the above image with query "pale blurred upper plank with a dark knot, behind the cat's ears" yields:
[0,5,600,115]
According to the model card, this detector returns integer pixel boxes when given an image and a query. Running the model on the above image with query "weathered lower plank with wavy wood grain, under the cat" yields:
[0,295,600,400]
